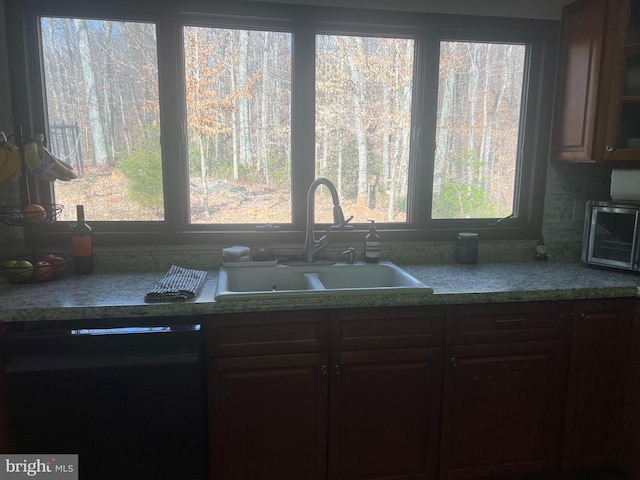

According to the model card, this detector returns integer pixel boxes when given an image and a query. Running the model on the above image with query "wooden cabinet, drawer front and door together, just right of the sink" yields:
[440,302,569,480]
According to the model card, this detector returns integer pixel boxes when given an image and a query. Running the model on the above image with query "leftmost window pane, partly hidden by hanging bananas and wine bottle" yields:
[40,17,164,222]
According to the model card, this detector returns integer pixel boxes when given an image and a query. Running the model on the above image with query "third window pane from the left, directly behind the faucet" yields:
[315,34,415,225]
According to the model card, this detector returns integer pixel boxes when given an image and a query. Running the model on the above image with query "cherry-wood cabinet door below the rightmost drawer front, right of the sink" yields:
[440,341,566,479]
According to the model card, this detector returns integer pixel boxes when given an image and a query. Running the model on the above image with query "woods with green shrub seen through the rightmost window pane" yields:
[432,42,526,218]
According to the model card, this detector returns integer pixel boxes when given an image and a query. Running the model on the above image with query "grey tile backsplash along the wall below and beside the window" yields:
[0,159,611,271]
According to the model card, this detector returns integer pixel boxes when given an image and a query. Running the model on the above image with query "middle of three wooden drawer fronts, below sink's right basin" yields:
[331,307,444,350]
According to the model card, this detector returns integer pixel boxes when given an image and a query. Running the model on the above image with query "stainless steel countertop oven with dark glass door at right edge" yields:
[582,201,640,272]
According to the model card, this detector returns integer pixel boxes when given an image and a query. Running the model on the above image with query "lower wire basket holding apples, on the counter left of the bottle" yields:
[0,253,73,283]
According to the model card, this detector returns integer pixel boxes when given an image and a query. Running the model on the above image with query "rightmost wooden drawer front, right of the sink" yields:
[446,302,571,345]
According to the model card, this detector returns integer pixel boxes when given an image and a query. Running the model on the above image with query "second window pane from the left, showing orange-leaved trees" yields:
[183,26,292,224]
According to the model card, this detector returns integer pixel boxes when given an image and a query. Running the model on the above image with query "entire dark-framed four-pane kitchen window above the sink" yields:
[3,0,556,245]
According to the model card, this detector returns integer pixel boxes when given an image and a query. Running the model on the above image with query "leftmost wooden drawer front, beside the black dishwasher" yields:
[206,311,328,357]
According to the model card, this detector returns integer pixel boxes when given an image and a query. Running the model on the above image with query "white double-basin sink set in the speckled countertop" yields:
[215,262,433,301]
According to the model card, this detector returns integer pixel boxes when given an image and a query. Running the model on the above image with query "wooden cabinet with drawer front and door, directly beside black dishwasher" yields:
[205,311,328,480]
